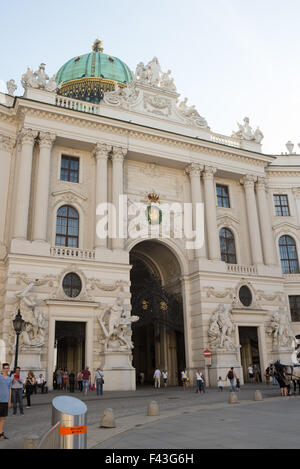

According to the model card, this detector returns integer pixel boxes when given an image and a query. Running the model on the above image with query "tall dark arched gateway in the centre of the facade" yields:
[130,241,186,385]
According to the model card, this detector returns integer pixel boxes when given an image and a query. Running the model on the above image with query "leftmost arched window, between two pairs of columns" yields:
[55,205,79,248]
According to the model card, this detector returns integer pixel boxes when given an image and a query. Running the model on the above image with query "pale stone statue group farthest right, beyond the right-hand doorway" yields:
[266,307,295,348]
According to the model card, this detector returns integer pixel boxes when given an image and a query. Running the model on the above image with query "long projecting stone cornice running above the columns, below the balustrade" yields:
[7,98,274,168]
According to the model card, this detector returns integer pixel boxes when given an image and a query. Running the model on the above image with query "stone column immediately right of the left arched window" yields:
[94,143,111,249]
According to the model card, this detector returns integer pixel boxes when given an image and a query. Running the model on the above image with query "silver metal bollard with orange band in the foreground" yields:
[52,396,87,449]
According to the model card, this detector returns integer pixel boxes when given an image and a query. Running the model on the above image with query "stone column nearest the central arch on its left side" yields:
[112,147,127,250]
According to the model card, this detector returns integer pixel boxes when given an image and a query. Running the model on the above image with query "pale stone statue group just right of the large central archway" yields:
[208,304,237,351]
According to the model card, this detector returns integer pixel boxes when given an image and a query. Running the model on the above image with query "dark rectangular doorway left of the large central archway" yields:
[55,321,86,374]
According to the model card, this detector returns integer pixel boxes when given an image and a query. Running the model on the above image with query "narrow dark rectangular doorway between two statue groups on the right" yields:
[239,326,263,383]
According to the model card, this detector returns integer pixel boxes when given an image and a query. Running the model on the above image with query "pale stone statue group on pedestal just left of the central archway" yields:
[98,298,139,351]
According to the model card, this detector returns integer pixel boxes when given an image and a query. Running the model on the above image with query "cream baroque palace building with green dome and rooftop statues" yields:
[0,40,300,390]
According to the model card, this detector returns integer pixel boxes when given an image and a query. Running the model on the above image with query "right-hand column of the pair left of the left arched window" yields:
[33,132,56,242]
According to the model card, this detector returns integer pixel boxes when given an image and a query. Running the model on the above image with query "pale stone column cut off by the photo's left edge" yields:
[0,135,14,250]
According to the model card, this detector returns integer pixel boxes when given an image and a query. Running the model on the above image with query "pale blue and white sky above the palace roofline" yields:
[0,0,300,153]
